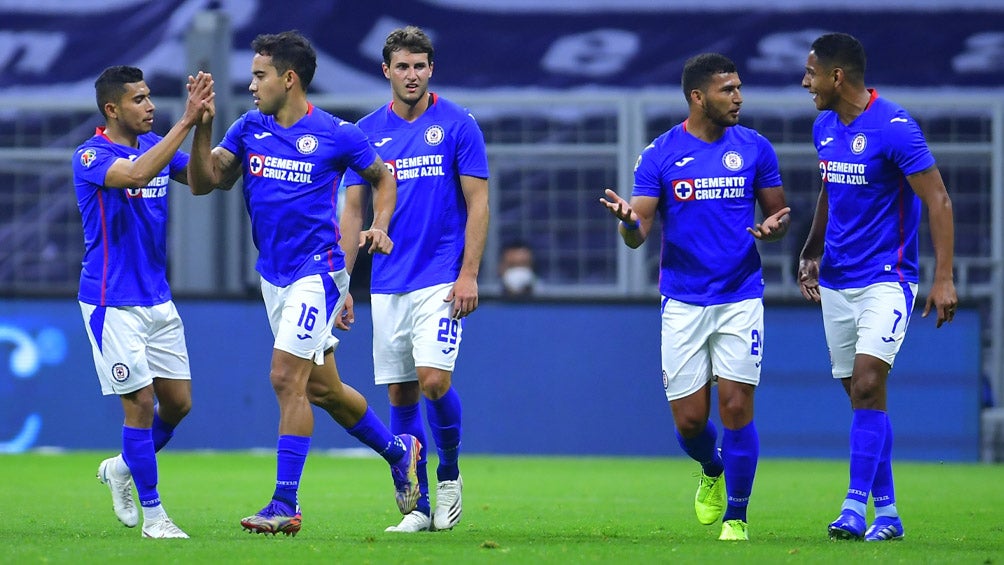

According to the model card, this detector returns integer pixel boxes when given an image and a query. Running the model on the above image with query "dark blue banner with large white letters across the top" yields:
[0,0,1004,96]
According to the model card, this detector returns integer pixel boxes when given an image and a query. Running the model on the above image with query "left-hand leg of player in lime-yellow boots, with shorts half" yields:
[661,298,725,525]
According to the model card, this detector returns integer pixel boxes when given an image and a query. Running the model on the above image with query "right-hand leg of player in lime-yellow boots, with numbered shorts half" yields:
[711,299,763,541]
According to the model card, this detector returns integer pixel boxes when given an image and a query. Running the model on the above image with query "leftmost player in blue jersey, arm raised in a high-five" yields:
[73,66,214,538]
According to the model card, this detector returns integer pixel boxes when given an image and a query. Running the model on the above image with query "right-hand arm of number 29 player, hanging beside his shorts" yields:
[447,175,489,318]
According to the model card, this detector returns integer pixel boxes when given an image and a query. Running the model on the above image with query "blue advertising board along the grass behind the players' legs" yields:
[0,299,980,461]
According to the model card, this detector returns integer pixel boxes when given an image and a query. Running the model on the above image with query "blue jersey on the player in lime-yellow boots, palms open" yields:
[632,121,781,306]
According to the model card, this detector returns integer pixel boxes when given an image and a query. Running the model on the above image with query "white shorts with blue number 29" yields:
[369,283,464,384]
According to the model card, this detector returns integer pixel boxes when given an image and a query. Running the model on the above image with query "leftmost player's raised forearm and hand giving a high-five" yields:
[104,72,216,189]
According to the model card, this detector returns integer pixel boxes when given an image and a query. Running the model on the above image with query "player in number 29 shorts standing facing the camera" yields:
[342,26,488,532]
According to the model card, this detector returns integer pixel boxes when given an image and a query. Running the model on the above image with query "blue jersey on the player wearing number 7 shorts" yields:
[812,90,935,289]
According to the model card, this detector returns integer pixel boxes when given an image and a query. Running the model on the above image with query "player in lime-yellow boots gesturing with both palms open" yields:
[599,53,790,541]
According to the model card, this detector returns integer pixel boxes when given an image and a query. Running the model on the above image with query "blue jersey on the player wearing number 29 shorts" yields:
[345,94,488,294]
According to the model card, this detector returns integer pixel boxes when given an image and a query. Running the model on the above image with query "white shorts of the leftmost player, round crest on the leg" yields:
[79,300,192,396]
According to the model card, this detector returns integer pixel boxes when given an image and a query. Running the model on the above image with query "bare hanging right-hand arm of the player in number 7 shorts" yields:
[907,166,959,327]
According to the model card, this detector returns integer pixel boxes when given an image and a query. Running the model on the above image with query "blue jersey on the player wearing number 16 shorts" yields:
[220,104,377,287]
